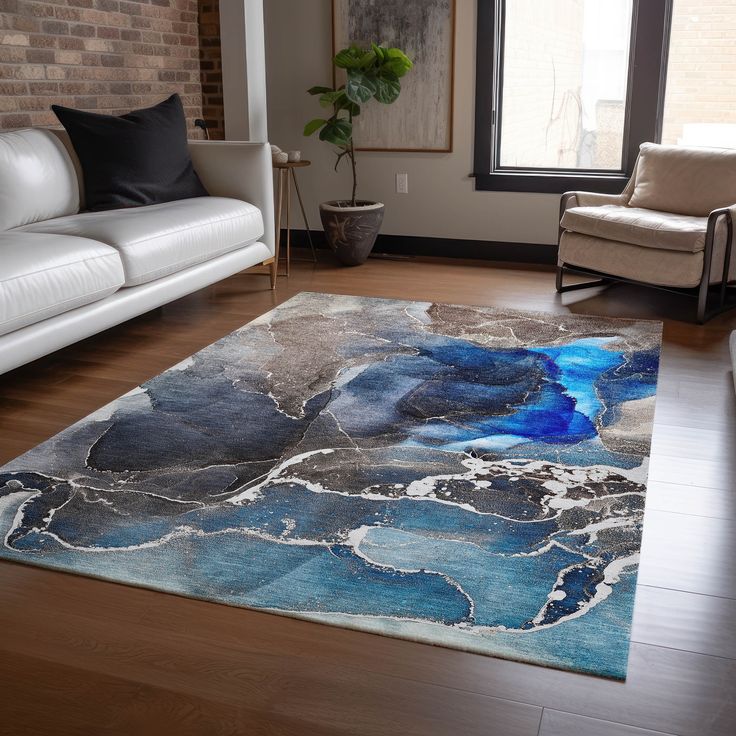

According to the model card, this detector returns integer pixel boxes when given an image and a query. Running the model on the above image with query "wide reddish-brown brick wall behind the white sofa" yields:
[0,0,202,137]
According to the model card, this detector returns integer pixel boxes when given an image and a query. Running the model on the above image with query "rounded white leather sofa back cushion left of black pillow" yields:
[0,128,79,230]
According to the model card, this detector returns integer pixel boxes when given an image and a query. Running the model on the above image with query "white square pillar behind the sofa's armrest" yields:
[220,0,268,141]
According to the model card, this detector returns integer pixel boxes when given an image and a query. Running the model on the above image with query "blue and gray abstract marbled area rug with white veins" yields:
[0,293,661,678]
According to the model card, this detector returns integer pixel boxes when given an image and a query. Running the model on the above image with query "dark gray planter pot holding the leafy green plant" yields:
[319,200,384,266]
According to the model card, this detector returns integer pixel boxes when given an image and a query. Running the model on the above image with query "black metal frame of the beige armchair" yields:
[556,192,736,325]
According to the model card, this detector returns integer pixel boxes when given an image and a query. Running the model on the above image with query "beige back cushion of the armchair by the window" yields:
[629,143,736,217]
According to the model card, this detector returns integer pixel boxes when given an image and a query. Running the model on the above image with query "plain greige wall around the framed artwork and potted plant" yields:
[265,0,559,244]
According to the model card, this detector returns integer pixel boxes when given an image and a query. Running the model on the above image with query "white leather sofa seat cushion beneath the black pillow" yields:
[16,197,263,286]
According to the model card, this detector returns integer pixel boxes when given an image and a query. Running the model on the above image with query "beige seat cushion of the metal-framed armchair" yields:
[561,205,724,253]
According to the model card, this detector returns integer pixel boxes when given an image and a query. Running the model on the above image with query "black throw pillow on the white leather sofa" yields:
[51,95,207,210]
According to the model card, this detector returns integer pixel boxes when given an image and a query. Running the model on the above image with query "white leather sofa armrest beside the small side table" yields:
[189,141,275,253]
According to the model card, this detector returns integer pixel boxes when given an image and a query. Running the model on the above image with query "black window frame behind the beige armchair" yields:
[473,0,673,194]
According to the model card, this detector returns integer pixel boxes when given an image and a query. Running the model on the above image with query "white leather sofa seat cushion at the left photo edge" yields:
[0,230,124,335]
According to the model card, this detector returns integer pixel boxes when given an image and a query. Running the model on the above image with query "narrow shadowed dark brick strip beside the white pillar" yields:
[199,0,225,140]
